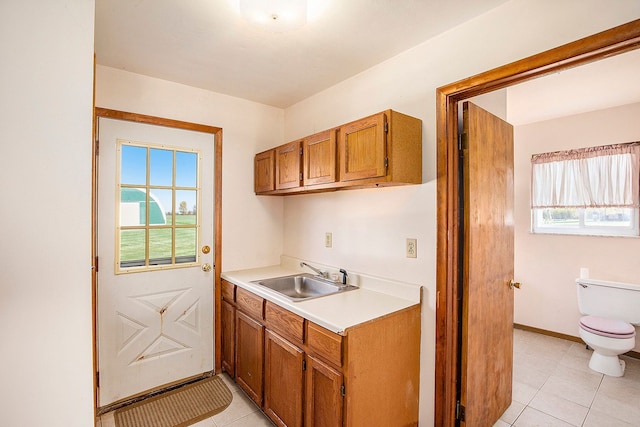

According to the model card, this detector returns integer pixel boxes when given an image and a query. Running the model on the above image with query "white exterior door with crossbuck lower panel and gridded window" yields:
[97,118,214,407]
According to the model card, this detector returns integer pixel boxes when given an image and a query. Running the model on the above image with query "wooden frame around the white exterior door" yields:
[91,107,222,413]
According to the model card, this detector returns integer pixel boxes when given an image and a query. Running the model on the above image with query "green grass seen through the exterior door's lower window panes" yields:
[120,215,197,261]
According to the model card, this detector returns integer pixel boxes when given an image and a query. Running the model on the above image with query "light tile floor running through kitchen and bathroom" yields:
[98,329,640,427]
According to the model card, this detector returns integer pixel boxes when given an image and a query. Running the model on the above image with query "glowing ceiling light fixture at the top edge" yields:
[239,0,307,33]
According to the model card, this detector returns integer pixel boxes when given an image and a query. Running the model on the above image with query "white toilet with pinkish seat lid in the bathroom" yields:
[576,279,640,377]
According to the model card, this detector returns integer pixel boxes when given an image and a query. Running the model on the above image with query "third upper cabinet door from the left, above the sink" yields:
[302,129,337,185]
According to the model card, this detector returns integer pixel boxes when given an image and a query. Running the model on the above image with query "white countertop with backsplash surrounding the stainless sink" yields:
[221,256,422,334]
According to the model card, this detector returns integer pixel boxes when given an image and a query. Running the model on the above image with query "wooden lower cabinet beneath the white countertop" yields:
[222,287,421,427]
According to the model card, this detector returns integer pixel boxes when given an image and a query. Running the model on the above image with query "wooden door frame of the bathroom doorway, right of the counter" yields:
[434,19,640,426]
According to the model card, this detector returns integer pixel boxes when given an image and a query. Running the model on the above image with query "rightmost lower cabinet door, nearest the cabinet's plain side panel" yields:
[305,356,343,427]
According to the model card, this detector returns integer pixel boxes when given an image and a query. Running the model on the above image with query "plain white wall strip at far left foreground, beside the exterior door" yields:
[0,0,94,427]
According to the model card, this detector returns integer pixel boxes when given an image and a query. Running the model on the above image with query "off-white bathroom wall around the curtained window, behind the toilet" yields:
[514,103,640,351]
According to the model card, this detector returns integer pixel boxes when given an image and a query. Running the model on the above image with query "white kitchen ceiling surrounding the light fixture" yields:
[95,0,507,108]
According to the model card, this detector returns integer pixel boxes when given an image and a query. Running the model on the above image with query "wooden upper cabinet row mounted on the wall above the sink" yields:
[255,110,422,195]
